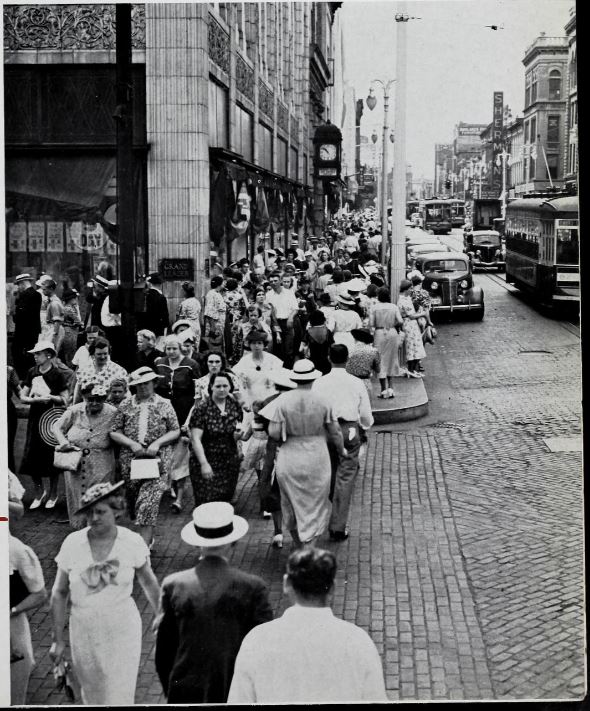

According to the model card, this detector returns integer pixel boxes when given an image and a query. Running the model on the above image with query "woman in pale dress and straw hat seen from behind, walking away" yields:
[260,358,347,545]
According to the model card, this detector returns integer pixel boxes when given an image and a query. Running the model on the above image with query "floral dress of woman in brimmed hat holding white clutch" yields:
[113,394,180,526]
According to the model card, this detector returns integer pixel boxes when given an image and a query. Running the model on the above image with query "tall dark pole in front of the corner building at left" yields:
[115,3,136,368]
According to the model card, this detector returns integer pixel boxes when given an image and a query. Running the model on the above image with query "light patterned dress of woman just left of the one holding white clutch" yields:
[56,402,117,529]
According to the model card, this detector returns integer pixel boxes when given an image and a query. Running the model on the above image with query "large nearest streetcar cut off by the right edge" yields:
[504,194,580,306]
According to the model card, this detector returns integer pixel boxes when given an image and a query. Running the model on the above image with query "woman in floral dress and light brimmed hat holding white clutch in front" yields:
[111,366,180,546]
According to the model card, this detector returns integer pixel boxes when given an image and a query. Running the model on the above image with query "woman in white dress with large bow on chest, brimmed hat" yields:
[49,482,160,706]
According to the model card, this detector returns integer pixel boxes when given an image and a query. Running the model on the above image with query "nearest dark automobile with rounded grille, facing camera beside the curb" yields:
[414,252,485,321]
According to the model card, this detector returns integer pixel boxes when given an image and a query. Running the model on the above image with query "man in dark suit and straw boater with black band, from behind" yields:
[155,502,272,704]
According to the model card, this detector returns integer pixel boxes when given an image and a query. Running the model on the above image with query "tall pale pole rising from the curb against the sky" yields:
[389,3,410,303]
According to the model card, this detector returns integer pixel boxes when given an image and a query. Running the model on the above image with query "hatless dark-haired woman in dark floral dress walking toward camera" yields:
[189,373,242,506]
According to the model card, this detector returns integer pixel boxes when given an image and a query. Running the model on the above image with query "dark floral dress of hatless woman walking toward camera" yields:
[190,397,242,506]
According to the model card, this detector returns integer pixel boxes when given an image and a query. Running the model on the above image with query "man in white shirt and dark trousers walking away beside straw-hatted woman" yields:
[312,344,373,541]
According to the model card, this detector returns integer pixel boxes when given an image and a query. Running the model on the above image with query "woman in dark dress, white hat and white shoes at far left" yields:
[20,341,71,509]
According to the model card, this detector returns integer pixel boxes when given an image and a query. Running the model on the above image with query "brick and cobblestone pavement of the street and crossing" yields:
[6,268,585,704]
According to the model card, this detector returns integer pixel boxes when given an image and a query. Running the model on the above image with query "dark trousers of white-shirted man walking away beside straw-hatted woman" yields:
[329,420,361,532]
